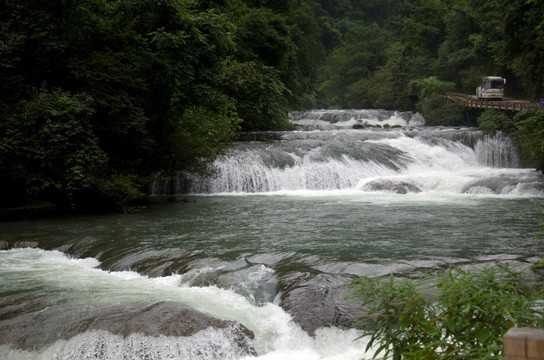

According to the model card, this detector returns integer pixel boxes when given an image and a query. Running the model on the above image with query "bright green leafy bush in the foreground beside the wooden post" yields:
[349,266,544,360]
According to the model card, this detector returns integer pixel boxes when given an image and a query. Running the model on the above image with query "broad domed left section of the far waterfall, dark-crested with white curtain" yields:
[185,141,409,193]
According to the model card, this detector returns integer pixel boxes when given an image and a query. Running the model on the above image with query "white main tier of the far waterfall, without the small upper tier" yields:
[152,129,544,196]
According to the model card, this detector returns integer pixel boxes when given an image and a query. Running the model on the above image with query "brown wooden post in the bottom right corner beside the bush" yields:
[503,328,544,360]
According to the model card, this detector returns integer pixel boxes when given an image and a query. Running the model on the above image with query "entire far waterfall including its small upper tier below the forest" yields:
[150,110,539,195]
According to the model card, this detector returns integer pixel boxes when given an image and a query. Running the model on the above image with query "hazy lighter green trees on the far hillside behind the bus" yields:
[316,0,544,109]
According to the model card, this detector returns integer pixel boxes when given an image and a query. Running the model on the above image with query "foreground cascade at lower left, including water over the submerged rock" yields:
[0,249,364,360]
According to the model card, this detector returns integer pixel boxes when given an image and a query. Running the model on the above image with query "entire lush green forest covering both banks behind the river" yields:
[0,0,544,208]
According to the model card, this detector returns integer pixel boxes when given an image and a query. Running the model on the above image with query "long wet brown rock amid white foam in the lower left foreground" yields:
[0,302,257,356]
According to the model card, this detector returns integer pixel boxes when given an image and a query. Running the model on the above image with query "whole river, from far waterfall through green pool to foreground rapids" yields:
[0,110,544,360]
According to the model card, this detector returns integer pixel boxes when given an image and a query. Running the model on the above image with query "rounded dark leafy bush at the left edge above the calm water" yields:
[0,88,107,208]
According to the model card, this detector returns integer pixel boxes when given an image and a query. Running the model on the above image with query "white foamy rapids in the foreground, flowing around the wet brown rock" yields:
[0,249,372,360]
